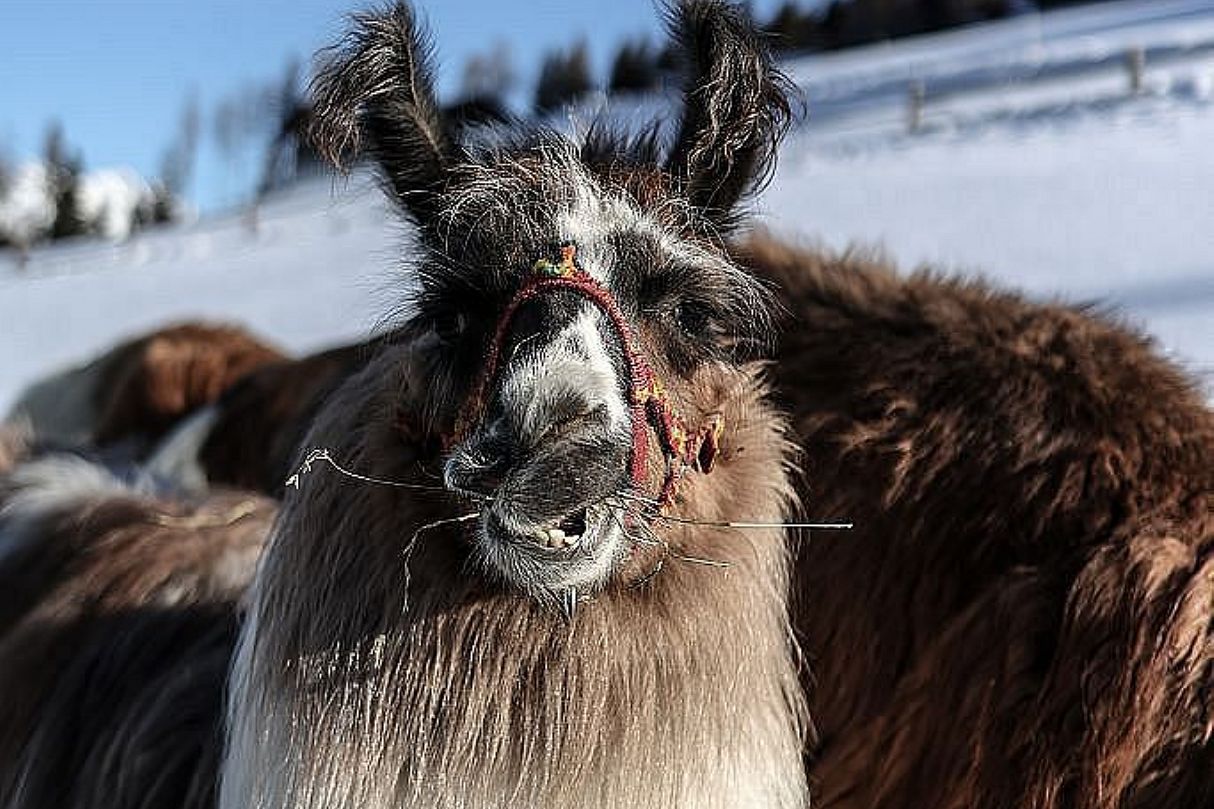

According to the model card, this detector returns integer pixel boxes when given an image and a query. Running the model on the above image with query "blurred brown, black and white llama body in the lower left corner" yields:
[0,456,274,809]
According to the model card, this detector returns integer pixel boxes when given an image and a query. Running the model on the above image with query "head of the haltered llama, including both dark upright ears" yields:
[314,0,789,598]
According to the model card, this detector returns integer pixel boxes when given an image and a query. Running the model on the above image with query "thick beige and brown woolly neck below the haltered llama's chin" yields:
[221,352,806,809]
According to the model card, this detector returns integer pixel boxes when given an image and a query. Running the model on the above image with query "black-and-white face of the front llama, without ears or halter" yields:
[418,148,765,596]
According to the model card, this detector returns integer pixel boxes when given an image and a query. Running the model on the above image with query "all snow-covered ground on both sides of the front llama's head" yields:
[0,0,1214,412]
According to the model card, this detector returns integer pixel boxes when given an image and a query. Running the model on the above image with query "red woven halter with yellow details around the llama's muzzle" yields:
[455,243,725,507]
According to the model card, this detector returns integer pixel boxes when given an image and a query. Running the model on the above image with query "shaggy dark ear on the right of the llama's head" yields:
[666,0,792,226]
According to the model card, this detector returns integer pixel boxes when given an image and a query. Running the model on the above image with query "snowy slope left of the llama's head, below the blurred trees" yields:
[0,173,402,411]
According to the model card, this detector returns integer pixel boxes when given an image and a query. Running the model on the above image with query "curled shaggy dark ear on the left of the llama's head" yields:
[310,2,455,221]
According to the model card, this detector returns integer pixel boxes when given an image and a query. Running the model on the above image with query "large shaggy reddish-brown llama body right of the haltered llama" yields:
[728,229,1214,809]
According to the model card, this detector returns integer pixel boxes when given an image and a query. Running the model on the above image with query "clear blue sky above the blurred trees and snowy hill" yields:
[0,0,786,209]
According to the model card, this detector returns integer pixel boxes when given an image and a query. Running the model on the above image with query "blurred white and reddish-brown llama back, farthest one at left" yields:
[7,323,283,454]
